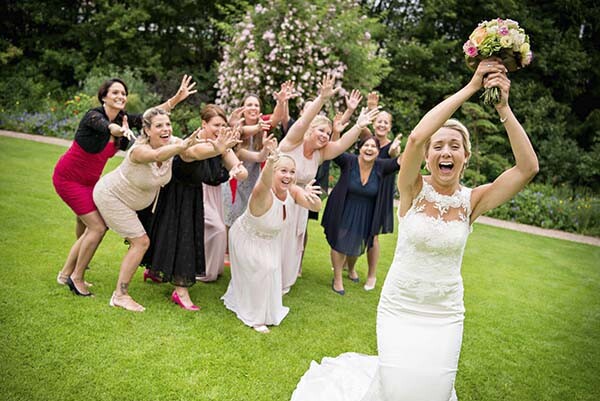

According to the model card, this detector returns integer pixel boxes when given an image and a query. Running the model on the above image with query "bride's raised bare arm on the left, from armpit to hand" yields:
[398,59,506,200]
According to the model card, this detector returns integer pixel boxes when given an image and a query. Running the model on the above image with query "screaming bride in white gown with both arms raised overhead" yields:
[292,59,538,401]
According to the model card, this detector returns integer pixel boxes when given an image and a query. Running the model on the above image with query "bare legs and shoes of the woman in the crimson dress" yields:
[61,211,106,294]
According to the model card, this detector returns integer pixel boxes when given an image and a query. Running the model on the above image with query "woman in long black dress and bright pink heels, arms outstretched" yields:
[142,105,247,311]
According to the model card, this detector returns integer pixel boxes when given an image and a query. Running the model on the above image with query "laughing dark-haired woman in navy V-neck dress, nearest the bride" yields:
[321,136,400,295]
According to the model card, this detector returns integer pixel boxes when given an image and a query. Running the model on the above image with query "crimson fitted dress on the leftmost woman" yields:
[52,141,118,216]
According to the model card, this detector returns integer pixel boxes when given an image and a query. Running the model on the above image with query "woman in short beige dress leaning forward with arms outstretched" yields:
[94,107,195,312]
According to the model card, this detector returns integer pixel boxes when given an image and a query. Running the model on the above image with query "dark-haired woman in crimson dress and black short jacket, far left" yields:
[52,75,196,296]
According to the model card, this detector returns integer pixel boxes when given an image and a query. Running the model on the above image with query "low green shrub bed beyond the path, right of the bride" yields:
[487,184,600,237]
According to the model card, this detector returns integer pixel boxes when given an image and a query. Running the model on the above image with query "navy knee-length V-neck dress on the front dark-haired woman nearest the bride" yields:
[321,153,400,256]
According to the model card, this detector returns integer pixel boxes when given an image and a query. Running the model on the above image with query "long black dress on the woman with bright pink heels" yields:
[138,156,229,287]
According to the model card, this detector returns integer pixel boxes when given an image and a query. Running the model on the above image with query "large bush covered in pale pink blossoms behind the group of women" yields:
[215,0,388,111]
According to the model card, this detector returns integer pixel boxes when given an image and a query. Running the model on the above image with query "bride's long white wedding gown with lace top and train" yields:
[292,180,471,401]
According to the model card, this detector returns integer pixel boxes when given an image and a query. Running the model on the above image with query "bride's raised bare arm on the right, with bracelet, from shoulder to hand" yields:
[471,73,539,222]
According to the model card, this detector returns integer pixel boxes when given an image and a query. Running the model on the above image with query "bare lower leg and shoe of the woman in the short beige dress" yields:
[111,234,150,312]
